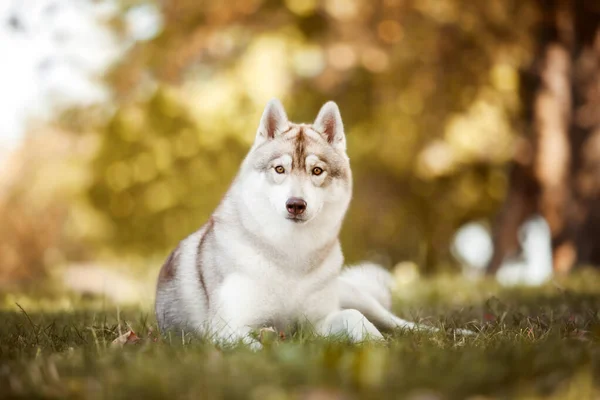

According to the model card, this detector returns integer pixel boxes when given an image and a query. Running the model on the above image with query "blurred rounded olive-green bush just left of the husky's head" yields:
[90,90,246,253]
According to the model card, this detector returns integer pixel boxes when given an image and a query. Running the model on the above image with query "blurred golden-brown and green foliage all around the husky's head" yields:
[48,0,538,269]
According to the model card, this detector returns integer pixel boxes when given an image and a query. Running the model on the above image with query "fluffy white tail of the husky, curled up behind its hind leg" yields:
[340,262,396,310]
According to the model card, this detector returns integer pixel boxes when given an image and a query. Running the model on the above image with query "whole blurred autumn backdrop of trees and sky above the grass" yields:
[0,0,600,396]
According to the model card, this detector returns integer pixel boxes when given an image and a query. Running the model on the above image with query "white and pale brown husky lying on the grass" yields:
[156,99,474,348]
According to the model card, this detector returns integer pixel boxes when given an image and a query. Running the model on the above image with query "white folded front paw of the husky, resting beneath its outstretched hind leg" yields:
[316,310,383,342]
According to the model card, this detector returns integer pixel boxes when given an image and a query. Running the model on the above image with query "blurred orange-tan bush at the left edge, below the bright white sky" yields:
[0,126,98,289]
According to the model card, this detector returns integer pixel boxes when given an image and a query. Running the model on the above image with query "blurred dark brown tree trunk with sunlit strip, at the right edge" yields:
[488,0,600,273]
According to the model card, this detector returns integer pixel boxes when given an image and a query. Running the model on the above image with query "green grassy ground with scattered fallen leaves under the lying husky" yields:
[0,272,600,400]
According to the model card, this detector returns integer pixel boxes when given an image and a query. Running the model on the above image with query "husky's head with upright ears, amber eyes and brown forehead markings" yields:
[238,99,352,233]
